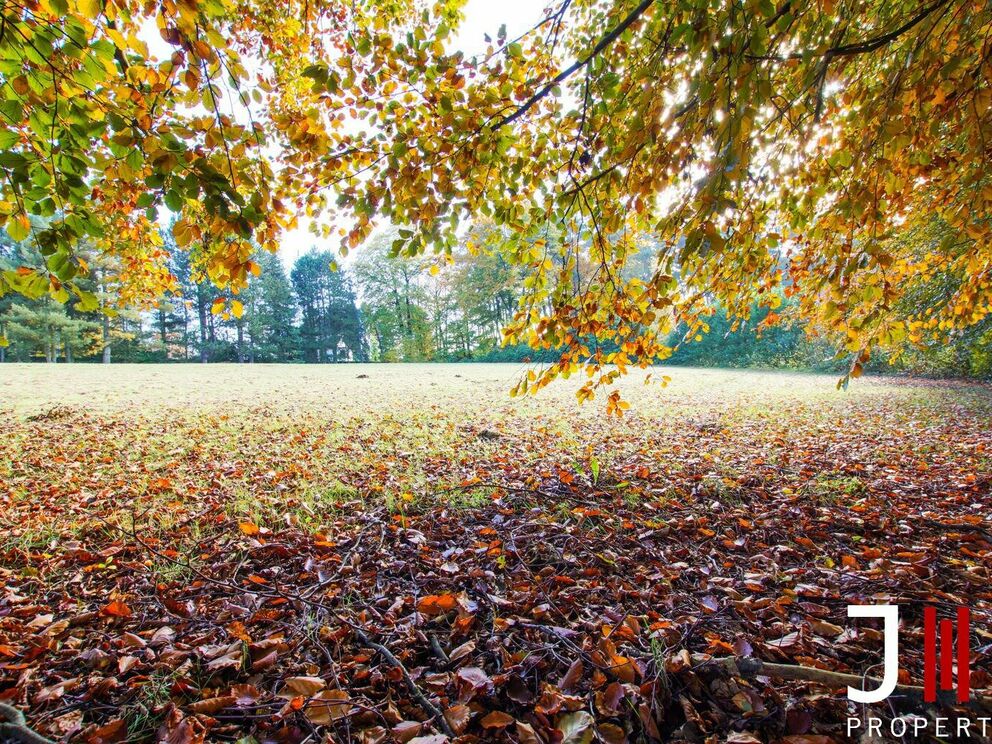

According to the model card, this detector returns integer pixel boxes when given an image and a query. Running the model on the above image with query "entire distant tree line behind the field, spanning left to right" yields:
[0,218,992,378]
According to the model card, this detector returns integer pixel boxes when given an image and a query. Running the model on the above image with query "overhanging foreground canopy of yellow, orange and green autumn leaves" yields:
[0,0,992,408]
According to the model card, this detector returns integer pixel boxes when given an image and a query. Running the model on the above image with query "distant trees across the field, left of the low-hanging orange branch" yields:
[0,222,521,364]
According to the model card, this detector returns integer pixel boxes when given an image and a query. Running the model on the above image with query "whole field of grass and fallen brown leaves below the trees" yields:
[0,364,992,742]
